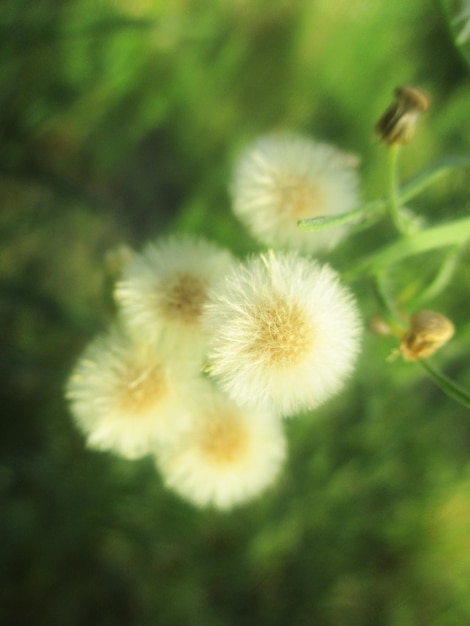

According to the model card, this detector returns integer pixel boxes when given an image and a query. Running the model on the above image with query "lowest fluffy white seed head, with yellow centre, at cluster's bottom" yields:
[157,382,286,509]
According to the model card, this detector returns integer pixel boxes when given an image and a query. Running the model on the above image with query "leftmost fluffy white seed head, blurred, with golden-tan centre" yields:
[66,329,198,458]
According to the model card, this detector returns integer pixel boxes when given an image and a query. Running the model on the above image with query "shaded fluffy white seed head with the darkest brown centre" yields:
[115,236,233,359]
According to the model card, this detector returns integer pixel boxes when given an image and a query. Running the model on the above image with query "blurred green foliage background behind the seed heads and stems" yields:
[0,0,470,626]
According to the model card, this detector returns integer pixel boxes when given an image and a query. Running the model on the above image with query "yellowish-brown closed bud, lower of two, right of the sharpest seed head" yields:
[400,311,455,361]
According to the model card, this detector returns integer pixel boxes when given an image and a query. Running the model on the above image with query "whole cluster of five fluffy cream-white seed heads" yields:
[67,136,361,509]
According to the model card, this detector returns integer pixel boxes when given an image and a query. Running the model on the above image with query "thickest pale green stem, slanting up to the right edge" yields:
[343,217,470,280]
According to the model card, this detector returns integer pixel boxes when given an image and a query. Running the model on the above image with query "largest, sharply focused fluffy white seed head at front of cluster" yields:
[203,252,361,415]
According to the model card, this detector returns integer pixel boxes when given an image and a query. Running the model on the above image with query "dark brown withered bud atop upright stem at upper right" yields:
[375,86,429,145]
